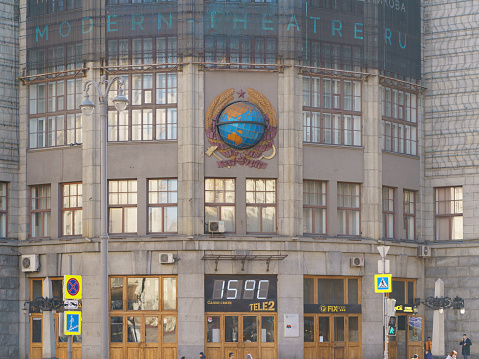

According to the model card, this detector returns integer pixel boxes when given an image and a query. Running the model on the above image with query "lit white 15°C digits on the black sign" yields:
[211,279,270,300]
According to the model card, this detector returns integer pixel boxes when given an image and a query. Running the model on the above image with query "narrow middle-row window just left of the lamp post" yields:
[61,182,83,236]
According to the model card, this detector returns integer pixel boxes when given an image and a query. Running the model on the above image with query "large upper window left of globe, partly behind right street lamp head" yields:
[108,72,178,142]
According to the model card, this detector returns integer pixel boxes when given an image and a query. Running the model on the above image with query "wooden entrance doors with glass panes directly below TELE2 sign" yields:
[205,313,277,359]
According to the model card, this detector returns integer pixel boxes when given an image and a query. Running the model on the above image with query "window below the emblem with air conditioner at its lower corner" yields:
[205,178,236,233]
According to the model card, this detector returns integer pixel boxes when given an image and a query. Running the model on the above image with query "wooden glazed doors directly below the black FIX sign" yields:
[304,314,361,359]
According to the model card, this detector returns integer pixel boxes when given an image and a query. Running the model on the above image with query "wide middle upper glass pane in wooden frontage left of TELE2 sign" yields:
[127,278,159,310]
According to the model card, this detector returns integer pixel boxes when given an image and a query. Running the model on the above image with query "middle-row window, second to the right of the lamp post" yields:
[148,179,178,233]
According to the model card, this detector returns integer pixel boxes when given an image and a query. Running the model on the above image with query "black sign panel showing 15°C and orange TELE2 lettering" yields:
[205,275,277,312]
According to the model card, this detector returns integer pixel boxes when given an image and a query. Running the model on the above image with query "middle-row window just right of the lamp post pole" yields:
[108,180,137,233]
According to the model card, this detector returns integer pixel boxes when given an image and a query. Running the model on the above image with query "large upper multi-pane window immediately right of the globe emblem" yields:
[303,76,361,146]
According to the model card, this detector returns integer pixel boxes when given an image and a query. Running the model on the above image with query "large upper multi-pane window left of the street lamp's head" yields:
[29,78,83,148]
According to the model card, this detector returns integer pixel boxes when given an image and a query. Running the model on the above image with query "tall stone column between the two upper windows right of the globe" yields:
[361,69,382,239]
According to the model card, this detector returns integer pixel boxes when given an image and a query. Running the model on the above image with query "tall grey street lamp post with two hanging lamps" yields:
[80,76,128,359]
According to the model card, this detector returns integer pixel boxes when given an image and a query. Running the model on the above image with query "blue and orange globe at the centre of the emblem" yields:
[216,102,266,150]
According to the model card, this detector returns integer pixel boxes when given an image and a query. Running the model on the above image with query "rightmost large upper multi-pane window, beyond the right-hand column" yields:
[382,87,418,156]
